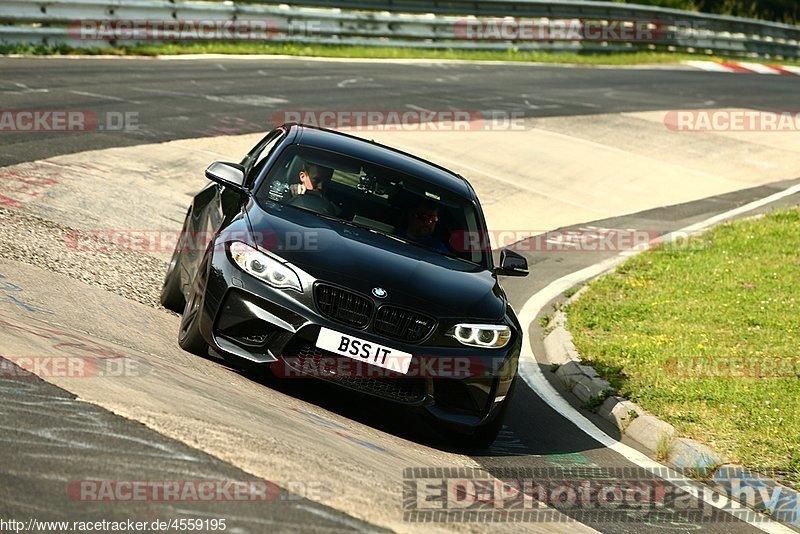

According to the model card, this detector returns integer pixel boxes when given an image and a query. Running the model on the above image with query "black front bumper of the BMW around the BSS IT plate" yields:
[200,247,521,432]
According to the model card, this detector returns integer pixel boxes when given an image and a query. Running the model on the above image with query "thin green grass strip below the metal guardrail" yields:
[0,42,800,65]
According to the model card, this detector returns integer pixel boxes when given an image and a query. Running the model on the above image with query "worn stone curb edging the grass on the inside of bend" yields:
[544,298,800,526]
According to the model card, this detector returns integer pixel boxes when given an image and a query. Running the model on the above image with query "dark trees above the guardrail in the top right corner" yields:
[628,0,800,24]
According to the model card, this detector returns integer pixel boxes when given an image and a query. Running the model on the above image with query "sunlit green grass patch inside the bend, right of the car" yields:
[569,208,800,488]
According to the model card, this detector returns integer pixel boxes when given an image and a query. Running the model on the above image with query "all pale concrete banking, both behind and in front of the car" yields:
[0,108,800,532]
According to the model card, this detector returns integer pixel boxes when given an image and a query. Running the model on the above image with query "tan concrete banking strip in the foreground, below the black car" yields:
[0,260,588,532]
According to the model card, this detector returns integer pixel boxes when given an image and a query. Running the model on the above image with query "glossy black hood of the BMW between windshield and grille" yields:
[248,203,506,321]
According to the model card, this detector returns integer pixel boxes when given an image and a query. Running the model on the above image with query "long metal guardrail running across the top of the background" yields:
[0,0,800,60]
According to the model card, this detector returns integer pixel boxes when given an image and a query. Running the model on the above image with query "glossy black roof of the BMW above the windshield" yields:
[284,123,475,200]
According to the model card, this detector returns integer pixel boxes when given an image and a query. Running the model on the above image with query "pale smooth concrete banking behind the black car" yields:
[0,111,800,259]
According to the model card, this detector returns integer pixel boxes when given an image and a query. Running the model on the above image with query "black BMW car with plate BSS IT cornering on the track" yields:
[161,124,528,446]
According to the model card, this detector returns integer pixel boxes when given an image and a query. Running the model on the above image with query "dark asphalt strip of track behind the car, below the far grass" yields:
[0,58,798,165]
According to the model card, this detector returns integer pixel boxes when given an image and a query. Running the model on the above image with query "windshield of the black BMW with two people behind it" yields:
[256,146,488,265]
